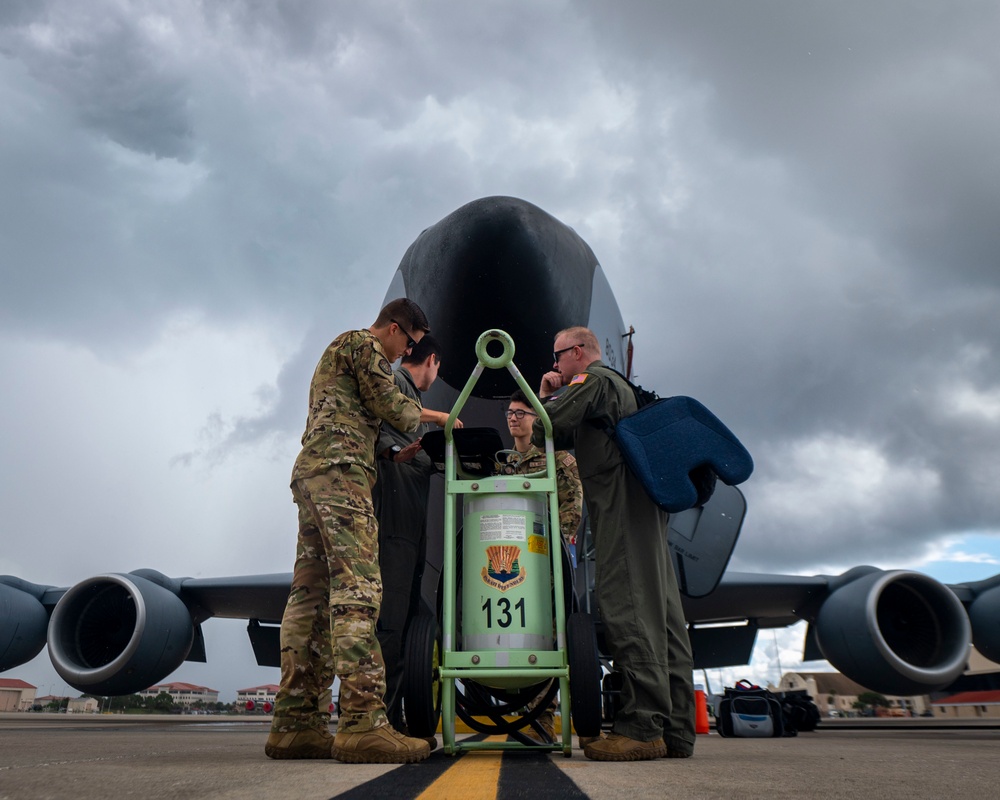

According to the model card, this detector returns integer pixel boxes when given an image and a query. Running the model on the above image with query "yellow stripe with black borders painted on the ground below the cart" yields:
[332,735,587,800]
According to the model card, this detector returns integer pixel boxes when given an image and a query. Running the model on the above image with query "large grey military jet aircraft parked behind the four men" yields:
[0,197,1000,695]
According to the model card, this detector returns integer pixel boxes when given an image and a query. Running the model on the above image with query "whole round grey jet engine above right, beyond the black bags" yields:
[815,570,972,696]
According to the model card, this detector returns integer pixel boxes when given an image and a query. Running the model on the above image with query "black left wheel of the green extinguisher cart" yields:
[403,614,441,736]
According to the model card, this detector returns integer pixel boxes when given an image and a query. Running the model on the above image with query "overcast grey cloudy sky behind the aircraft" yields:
[0,0,1000,699]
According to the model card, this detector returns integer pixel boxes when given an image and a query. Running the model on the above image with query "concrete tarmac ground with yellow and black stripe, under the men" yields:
[0,713,1000,800]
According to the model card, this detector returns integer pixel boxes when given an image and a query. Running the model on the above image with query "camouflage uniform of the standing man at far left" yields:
[271,330,420,732]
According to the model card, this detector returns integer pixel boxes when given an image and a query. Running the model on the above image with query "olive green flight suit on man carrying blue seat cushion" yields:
[532,361,695,754]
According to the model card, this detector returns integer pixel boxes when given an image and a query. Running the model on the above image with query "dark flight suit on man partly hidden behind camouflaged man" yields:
[372,367,436,730]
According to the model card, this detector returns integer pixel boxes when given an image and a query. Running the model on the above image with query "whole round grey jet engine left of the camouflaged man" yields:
[49,574,194,695]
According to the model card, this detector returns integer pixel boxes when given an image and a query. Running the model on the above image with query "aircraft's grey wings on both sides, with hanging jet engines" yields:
[7,567,1000,695]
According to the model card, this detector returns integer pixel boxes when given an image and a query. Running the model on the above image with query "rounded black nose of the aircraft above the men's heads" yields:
[399,197,597,397]
